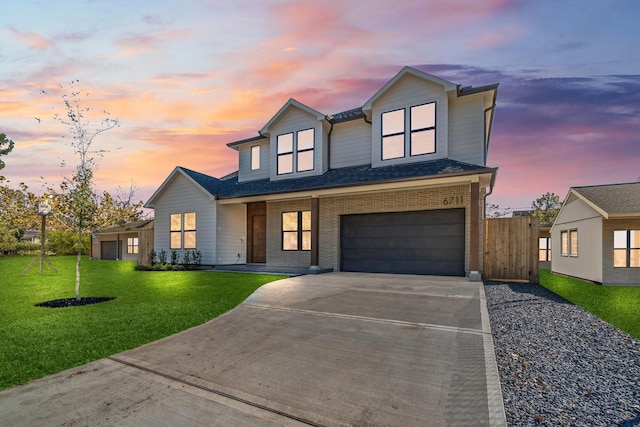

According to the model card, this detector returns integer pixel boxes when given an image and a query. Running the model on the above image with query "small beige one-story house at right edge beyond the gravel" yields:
[551,182,640,285]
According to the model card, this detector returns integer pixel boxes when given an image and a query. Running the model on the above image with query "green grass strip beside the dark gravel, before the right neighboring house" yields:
[540,270,640,339]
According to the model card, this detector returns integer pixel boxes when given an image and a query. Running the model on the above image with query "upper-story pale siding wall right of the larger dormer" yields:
[449,94,485,166]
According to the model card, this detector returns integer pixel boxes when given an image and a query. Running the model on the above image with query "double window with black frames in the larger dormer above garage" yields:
[382,102,436,160]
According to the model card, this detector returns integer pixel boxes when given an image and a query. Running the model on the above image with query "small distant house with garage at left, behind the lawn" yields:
[91,219,153,264]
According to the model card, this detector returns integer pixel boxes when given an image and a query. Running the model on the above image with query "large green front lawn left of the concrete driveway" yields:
[0,257,282,389]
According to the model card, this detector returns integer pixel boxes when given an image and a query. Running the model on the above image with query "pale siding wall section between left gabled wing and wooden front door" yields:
[217,204,247,264]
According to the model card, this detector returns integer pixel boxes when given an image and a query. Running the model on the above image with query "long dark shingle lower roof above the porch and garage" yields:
[181,159,496,199]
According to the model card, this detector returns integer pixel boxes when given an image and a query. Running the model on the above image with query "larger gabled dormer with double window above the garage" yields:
[362,67,457,167]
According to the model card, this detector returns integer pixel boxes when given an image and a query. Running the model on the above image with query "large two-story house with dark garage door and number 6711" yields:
[145,67,498,279]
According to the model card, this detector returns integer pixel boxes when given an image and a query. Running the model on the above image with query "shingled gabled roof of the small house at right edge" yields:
[567,182,640,219]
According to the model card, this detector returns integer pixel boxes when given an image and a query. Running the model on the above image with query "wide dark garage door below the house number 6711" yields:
[340,209,465,276]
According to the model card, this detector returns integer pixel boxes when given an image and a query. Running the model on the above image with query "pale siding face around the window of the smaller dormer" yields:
[269,108,326,180]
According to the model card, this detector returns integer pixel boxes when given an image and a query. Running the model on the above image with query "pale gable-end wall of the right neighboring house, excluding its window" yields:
[551,200,602,283]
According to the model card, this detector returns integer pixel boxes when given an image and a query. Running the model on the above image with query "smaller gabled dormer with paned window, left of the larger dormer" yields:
[260,99,329,180]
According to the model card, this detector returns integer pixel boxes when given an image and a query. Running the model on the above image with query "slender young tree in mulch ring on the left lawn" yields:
[54,80,120,300]
